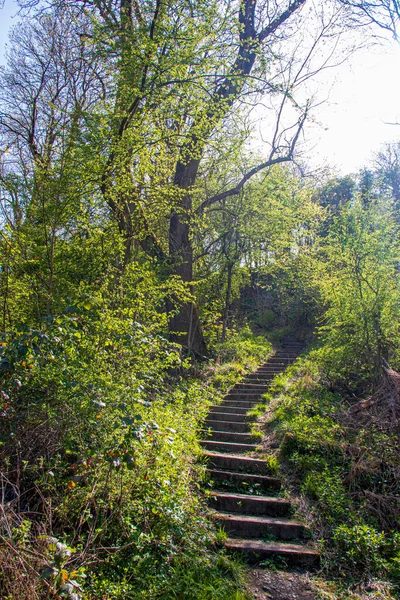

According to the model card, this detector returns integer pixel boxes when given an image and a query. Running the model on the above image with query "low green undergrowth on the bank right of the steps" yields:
[264,350,400,599]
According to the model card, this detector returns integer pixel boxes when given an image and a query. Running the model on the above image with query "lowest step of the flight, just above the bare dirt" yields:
[225,538,320,568]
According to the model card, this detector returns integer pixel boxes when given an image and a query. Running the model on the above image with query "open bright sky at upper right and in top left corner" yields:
[0,0,400,174]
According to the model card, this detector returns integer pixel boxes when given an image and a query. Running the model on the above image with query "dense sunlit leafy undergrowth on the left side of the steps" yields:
[0,282,271,600]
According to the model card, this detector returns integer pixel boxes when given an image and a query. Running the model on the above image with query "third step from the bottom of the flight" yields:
[210,491,290,517]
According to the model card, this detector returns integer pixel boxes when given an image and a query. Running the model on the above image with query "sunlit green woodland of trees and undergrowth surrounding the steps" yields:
[0,0,400,600]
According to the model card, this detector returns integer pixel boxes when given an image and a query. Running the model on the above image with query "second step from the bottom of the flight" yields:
[213,512,304,540]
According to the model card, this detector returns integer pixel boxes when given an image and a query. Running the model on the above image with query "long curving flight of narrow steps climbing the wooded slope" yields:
[202,340,319,568]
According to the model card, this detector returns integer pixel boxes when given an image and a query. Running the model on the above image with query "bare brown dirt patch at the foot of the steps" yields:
[249,569,317,600]
